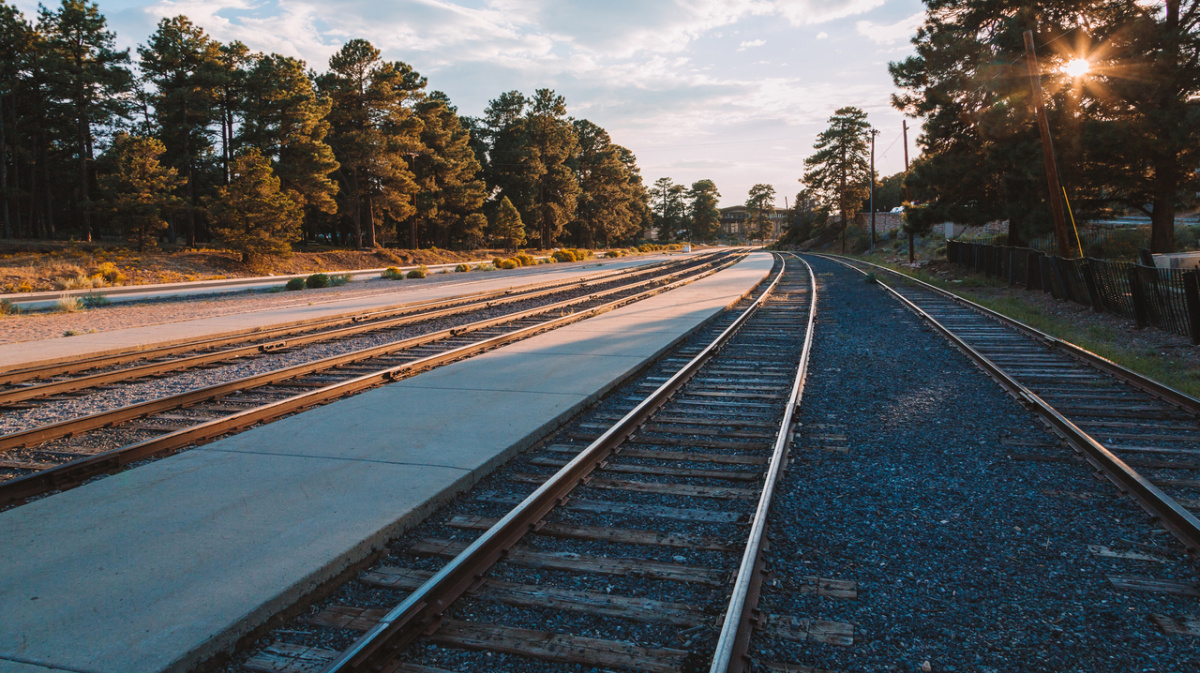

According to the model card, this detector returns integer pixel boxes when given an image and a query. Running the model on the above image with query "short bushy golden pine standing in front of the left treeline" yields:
[209,148,301,263]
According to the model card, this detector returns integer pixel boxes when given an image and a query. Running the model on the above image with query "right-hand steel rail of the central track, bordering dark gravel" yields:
[709,256,817,673]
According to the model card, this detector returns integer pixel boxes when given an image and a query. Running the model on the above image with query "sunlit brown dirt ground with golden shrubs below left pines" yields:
[0,241,538,293]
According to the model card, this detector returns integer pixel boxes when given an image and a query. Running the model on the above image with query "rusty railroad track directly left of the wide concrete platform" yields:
[0,250,739,506]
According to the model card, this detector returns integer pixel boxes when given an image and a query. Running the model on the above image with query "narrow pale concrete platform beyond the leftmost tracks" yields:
[0,254,686,371]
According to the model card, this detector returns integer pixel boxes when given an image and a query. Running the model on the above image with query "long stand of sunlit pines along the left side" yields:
[0,0,657,254]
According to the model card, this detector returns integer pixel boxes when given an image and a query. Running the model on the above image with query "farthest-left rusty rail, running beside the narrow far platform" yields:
[0,253,700,385]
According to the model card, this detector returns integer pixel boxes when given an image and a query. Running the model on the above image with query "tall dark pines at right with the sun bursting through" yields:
[890,0,1200,252]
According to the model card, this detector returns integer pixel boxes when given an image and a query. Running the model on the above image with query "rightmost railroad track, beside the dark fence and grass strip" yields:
[821,256,1200,553]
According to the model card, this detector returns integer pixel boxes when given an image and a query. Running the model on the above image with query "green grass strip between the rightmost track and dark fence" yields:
[864,254,1200,397]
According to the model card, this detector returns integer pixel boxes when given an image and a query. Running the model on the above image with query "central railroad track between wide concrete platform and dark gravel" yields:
[229,250,820,673]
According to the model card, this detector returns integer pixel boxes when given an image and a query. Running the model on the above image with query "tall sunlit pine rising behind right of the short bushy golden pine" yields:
[238,54,338,239]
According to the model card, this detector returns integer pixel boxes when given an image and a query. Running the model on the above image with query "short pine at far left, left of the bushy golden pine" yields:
[100,134,182,252]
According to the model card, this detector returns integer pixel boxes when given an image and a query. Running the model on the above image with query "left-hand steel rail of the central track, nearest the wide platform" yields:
[322,253,784,673]
